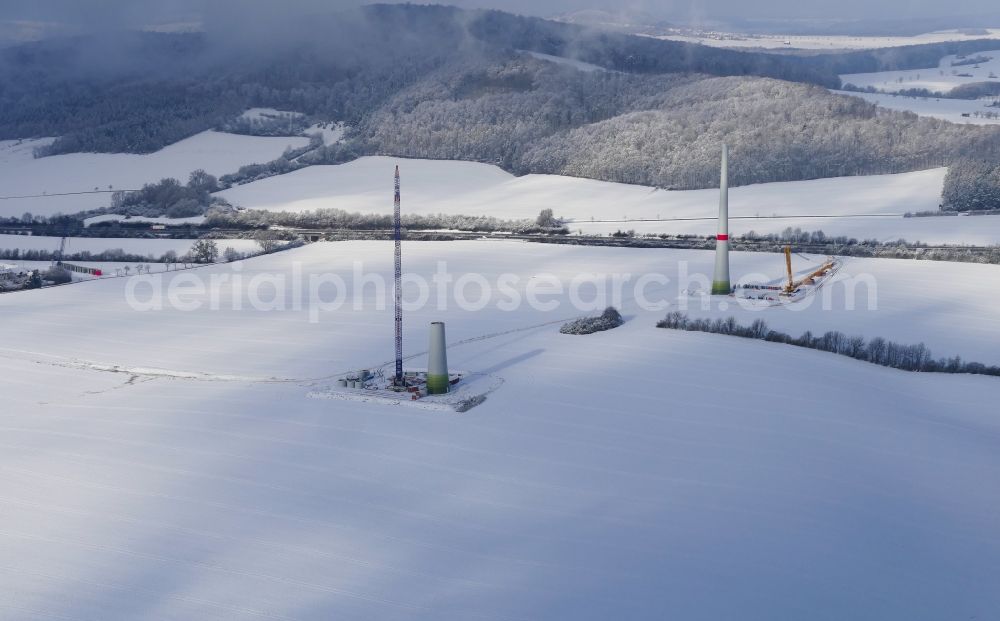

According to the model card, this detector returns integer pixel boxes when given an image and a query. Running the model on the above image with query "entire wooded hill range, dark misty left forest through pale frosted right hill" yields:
[0,5,1000,194]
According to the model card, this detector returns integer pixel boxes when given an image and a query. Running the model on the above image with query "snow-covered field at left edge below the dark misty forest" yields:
[0,132,308,217]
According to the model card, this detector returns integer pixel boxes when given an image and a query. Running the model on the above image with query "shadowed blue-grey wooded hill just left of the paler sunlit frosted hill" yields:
[358,55,701,172]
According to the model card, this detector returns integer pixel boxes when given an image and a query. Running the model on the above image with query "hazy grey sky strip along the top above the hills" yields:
[0,0,998,26]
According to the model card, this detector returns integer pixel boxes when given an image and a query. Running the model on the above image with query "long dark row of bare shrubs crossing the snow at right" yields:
[656,311,1000,376]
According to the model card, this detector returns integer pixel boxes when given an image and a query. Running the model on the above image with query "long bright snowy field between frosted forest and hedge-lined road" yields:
[220,157,1000,244]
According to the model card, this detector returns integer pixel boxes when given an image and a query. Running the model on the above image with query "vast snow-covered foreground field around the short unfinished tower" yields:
[0,242,1000,621]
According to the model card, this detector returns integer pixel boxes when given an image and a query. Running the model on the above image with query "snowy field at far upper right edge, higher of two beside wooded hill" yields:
[840,50,1000,93]
